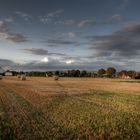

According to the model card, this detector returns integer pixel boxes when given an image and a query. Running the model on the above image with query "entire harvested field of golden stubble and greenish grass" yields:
[0,77,140,140]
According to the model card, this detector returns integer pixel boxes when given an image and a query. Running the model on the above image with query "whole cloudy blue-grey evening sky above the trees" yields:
[0,0,140,71]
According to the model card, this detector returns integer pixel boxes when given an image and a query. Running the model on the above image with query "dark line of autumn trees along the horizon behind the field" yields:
[2,67,140,79]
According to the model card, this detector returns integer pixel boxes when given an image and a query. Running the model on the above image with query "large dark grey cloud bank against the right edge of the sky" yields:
[89,22,140,58]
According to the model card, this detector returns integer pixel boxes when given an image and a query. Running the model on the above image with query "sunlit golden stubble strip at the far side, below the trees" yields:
[5,77,140,95]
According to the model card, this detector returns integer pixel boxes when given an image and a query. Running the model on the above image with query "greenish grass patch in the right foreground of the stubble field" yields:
[47,92,140,140]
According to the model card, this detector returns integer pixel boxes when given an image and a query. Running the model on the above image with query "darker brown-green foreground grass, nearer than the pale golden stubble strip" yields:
[0,78,140,140]
